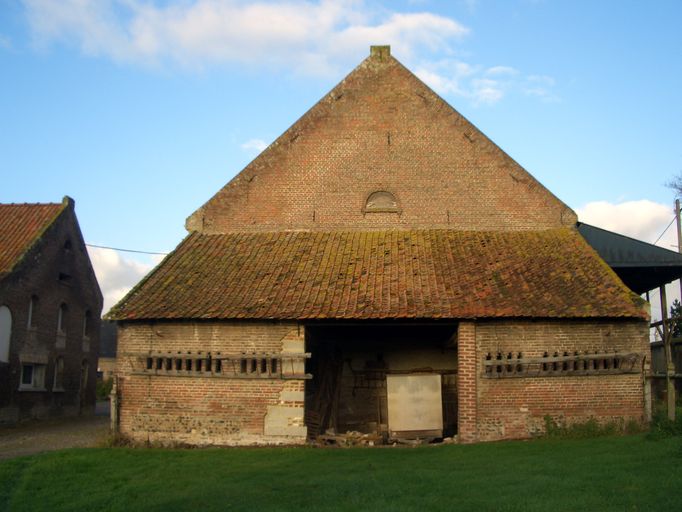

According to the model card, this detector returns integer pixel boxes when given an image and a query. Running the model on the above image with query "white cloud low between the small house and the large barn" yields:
[88,247,161,314]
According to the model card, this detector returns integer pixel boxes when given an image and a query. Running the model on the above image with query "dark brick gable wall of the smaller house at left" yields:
[0,206,102,424]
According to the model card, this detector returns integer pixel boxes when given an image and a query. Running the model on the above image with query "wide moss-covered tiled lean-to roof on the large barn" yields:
[108,229,647,320]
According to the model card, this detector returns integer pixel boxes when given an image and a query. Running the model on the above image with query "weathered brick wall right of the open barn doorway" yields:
[470,320,650,441]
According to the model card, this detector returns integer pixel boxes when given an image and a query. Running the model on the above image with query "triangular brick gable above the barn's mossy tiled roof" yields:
[186,47,577,233]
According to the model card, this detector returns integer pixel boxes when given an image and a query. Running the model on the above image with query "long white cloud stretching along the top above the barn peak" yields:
[24,0,469,74]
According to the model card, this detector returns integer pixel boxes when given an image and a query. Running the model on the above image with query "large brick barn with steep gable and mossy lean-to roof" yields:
[109,46,649,444]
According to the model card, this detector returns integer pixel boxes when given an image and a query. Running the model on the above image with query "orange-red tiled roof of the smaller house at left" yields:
[0,202,66,279]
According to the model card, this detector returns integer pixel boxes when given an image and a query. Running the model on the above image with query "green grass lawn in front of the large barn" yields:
[0,435,682,512]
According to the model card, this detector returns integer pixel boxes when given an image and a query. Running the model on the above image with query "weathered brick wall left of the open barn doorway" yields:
[117,322,306,445]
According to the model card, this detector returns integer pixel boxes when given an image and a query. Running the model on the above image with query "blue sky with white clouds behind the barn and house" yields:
[0,0,682,305]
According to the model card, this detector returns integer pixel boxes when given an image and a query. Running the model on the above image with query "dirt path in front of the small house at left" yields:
[0,403,109,460]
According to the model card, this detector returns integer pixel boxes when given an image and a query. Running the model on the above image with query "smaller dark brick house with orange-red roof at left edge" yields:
[0,197,102,424]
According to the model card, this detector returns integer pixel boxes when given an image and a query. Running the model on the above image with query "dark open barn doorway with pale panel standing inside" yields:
[305,322,457,441]
